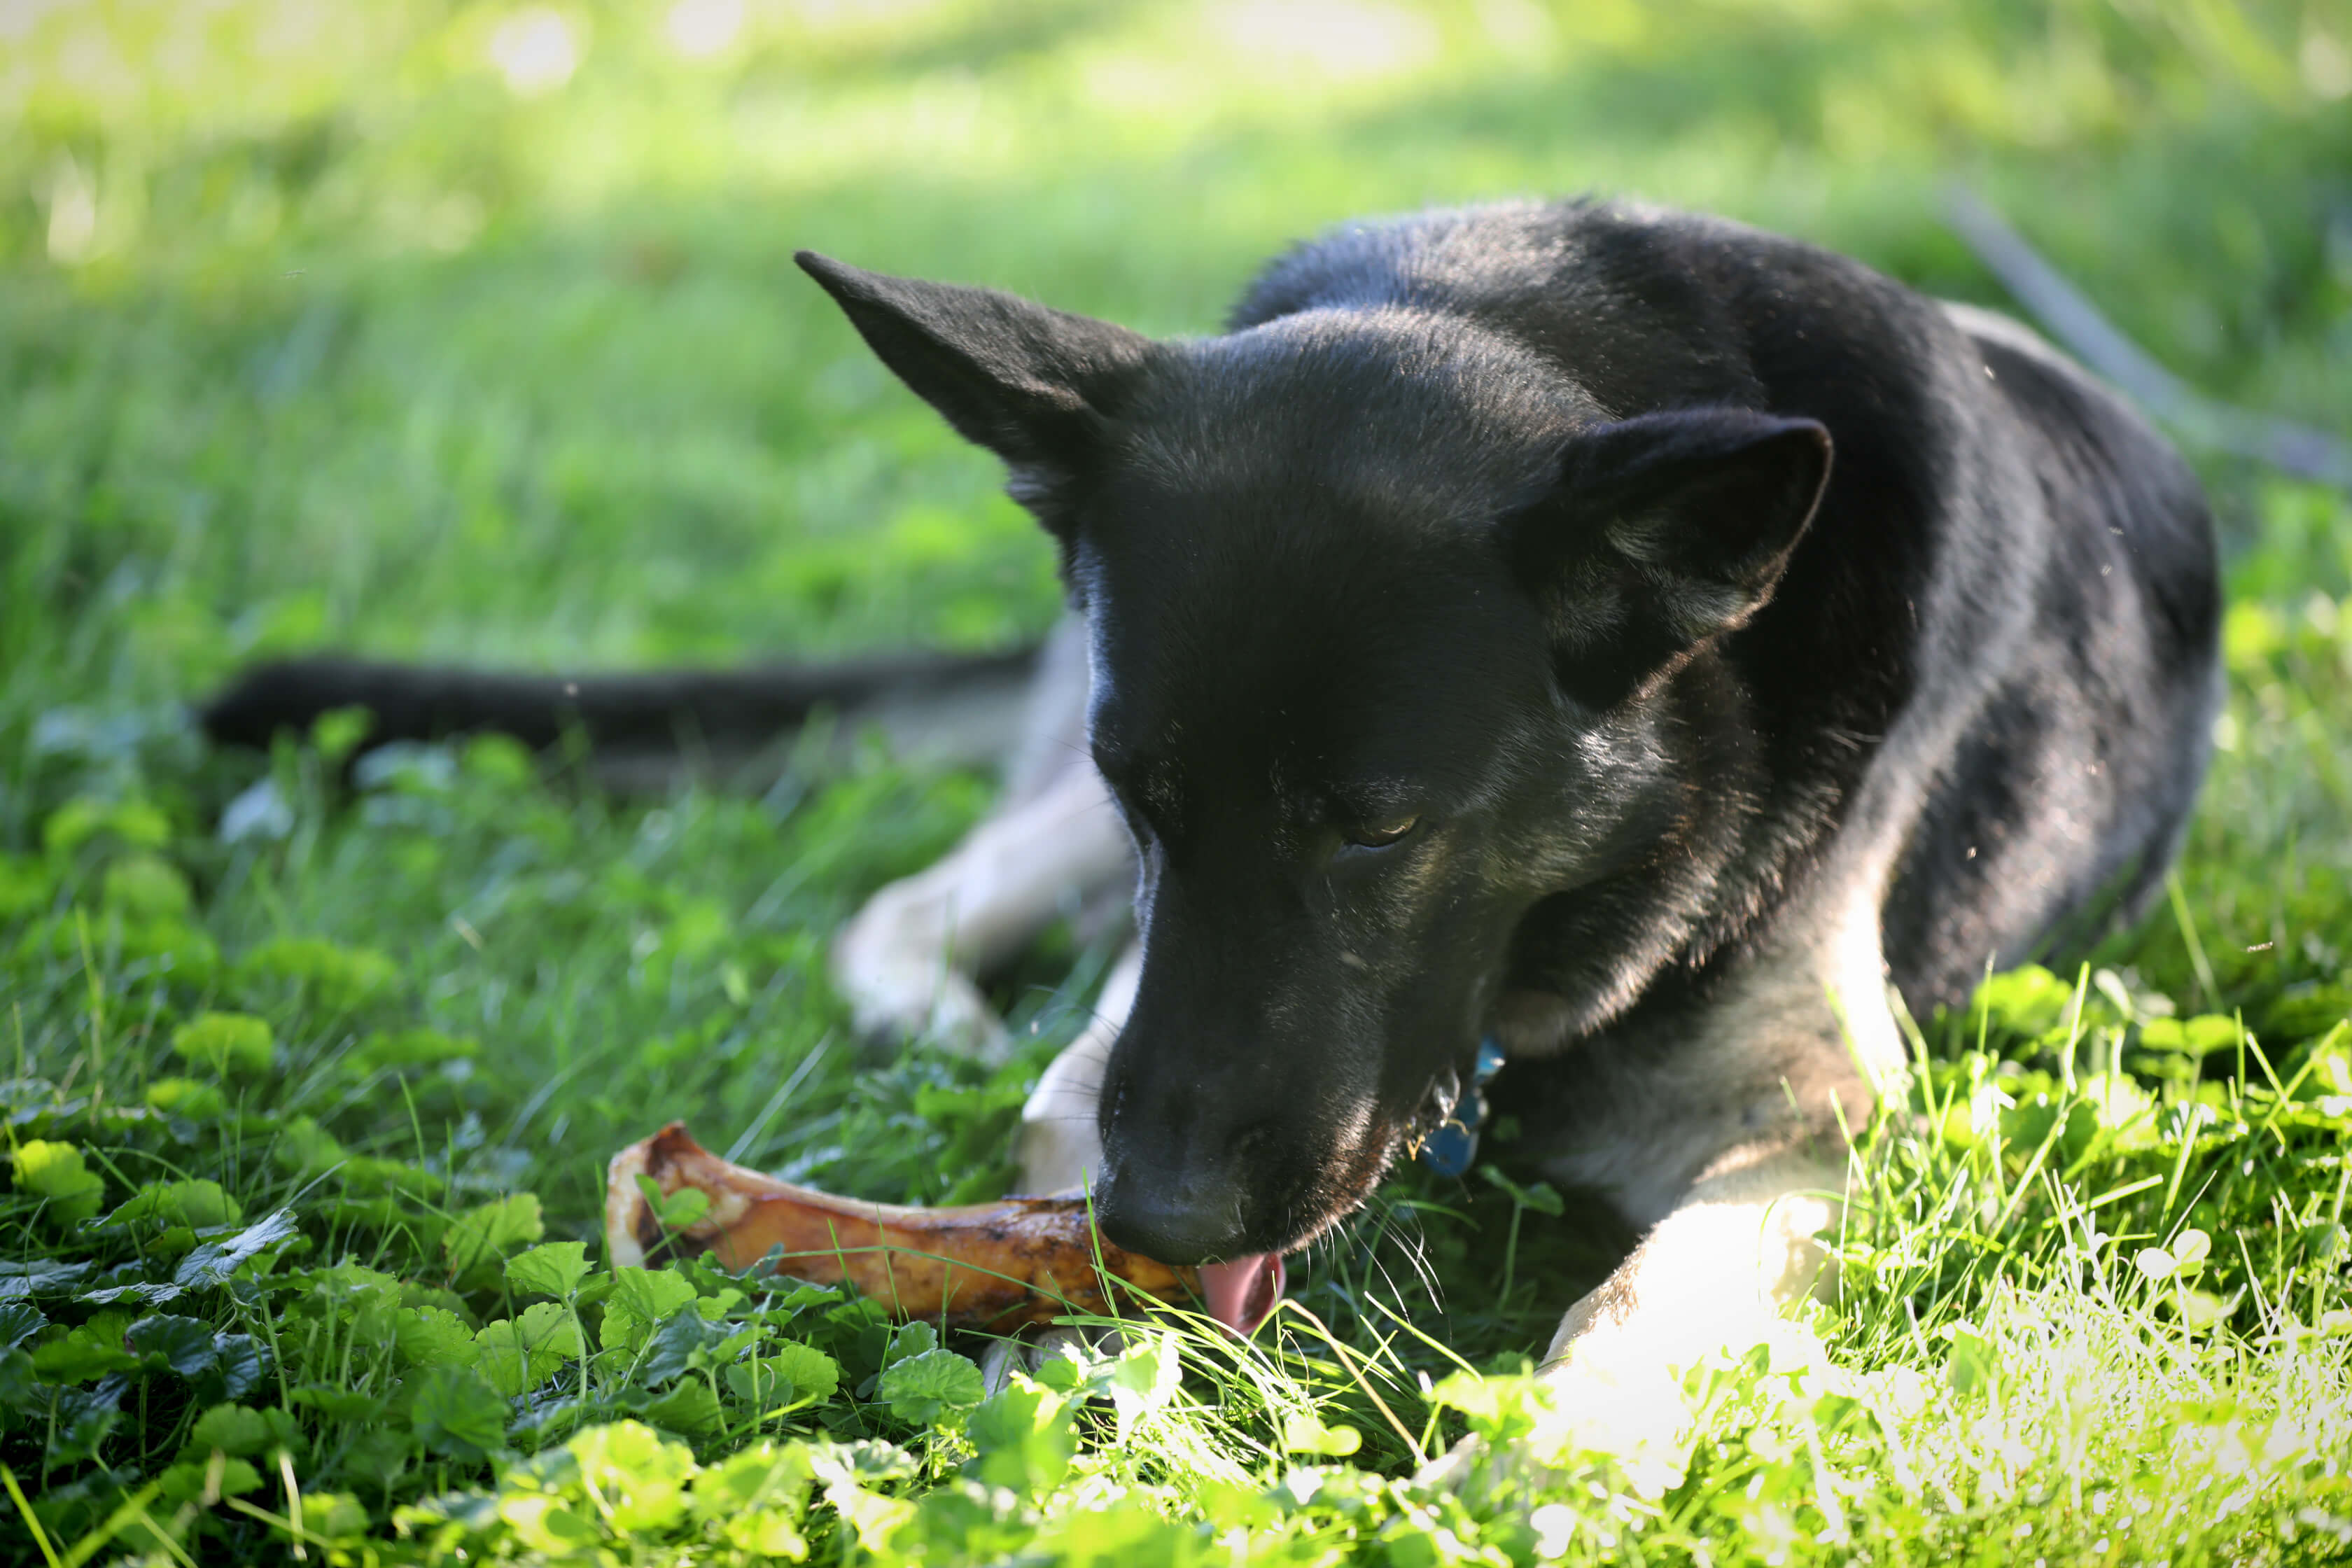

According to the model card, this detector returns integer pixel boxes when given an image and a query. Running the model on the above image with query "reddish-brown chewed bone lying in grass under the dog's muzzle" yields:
[605,1121,1197,1333]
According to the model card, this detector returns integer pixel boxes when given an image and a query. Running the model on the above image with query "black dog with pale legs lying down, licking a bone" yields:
[209,200,2218,1476]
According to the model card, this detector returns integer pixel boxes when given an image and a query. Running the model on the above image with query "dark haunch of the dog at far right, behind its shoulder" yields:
[1884,306,2220,1006]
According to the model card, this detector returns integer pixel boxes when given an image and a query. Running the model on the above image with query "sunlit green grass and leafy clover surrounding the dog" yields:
[0,0,2352,1563]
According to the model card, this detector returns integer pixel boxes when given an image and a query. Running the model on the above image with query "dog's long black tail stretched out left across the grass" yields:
[195,647,1040,788]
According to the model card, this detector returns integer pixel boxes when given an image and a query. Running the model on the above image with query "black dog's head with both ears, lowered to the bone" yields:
[802,256,1830,1262]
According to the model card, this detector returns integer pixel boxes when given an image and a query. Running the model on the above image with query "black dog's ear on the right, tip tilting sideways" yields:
[1503,409,1830,708]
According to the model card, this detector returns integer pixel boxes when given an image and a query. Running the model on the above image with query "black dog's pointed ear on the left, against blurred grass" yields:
[795,251,1152,533]
